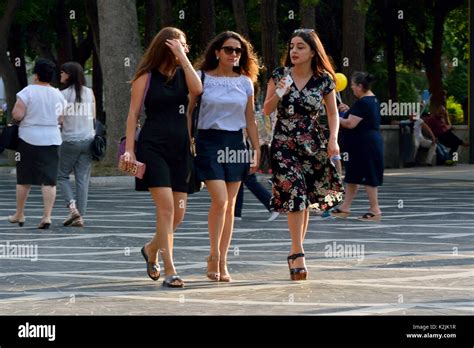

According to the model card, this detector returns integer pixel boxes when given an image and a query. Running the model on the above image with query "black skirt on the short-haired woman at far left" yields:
[15,139,59,186]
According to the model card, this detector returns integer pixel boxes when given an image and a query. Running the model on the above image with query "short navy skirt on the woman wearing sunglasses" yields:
[194,129,251,182]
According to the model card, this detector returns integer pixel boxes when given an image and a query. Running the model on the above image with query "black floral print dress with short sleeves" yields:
[270,67,344,212]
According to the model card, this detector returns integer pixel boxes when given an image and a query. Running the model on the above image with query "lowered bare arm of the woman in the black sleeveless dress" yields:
[124,74,148,161]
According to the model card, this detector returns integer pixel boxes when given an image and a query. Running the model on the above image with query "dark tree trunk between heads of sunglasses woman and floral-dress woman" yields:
[260,0,278,95]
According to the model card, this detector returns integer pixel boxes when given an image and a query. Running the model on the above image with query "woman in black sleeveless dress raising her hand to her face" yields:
[124,27,202,287]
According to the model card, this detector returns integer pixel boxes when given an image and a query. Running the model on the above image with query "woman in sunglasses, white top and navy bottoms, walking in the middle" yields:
[188,31,260,282]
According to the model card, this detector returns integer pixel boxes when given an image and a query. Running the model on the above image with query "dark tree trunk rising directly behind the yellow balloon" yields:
[342,0,367,105]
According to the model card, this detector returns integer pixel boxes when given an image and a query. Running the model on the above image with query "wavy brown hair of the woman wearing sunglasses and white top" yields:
[197,31,260,83]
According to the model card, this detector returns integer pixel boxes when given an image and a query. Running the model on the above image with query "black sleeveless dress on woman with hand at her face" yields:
[135,68,192,192]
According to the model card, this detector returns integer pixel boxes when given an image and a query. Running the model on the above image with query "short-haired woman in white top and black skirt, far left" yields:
[8,59,65,229]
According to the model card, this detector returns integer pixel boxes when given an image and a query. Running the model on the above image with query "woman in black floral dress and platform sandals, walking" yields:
[264,29,343,280]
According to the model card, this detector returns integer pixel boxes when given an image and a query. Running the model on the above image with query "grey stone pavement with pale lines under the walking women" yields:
[0,175,474,315]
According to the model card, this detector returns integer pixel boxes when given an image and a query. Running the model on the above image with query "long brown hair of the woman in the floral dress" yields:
[283,31,336,81]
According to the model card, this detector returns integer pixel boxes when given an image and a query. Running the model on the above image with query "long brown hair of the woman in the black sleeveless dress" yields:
[132,27,186,82]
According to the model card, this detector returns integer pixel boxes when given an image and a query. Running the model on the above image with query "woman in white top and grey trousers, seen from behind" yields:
[58,62,95,227]
